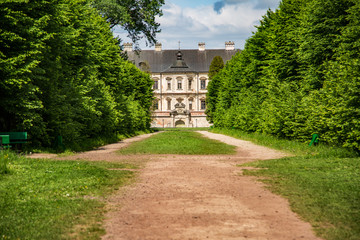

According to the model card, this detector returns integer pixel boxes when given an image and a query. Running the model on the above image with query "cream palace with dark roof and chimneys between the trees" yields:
[124,42,240,128]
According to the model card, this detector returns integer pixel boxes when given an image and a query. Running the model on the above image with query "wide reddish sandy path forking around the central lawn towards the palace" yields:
[99,132,319,240]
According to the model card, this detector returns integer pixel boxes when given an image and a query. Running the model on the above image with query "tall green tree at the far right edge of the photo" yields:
[312,1,360,150]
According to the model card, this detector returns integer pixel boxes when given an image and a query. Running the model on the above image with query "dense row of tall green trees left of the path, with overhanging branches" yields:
[0,0,163,147]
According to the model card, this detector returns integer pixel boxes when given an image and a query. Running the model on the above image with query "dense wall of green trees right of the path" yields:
[208,0,360,150]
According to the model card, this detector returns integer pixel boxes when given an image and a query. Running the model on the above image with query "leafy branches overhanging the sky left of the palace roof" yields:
[93,0,164,44]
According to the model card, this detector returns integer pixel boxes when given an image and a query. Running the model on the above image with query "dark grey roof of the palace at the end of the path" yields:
[127,49,240,73]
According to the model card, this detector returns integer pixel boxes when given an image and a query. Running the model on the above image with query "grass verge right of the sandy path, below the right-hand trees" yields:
[213,129,360,240]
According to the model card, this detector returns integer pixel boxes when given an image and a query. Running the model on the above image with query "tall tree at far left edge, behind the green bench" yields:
[0,1,49,131]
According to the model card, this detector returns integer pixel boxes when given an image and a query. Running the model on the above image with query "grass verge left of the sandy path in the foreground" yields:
[0,152,134,239]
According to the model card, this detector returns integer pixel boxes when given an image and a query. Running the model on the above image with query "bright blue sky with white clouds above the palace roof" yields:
[114,0,280,49]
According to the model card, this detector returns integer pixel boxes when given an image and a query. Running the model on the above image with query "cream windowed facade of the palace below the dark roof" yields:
[152,73,210,128]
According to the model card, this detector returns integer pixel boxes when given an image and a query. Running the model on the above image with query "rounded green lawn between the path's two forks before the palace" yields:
[119,129,236,155]
